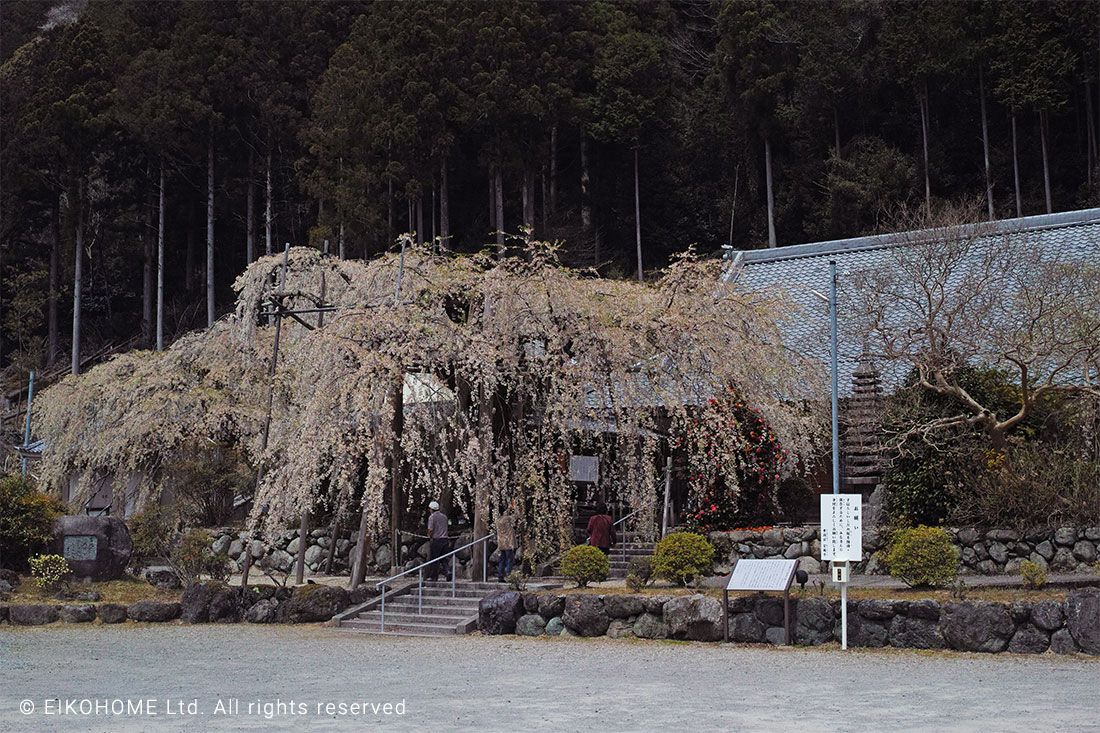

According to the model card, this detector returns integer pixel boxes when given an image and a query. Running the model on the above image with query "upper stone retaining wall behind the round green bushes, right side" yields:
[708,526,1100,576]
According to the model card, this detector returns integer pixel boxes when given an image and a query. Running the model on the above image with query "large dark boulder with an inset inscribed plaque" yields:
[53,514,133,580]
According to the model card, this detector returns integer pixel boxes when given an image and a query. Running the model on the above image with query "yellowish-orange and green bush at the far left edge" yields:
[0,475,65,570]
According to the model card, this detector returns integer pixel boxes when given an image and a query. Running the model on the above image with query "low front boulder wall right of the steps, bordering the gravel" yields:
[479,589,1100,655]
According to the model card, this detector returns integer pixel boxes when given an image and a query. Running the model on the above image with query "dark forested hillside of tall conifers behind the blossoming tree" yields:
[0,0,1100,376]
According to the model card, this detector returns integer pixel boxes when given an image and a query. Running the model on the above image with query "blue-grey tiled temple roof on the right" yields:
[724,209,1100,396]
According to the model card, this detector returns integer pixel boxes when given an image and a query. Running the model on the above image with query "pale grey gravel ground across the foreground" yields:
[0,624,1100,731]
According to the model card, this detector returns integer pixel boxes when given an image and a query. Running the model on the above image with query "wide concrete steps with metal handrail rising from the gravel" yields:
[340,580,508,636]
